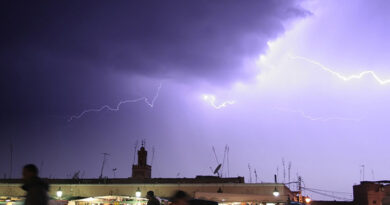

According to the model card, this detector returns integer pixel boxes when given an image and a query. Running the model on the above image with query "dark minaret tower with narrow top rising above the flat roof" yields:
[132,141,152,179]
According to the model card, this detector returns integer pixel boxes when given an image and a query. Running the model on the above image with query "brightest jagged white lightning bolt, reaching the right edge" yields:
[289,55,390,85]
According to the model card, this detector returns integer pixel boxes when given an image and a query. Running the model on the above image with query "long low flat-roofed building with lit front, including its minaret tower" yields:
[0,146,297,205]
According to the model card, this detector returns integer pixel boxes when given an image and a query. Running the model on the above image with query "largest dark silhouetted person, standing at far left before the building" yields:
[22,164,49,205]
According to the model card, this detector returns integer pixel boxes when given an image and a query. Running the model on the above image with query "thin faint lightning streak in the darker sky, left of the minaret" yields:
[68,83,162,122]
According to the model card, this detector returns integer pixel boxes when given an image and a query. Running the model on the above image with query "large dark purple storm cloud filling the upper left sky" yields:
[0,0,306,117]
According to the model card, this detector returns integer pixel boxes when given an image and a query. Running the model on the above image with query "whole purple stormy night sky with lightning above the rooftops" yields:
[0,0,390,200]
